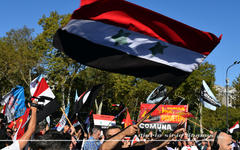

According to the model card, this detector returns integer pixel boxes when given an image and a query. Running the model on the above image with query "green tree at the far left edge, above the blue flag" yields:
[0,26,41,94]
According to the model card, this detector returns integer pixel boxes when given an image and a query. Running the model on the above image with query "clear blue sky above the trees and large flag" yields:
[0,0,240,86]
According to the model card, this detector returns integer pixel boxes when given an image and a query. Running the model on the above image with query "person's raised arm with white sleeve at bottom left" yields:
[1,101,37,150]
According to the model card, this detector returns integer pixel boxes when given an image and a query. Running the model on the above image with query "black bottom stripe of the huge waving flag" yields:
[54,29,190,87]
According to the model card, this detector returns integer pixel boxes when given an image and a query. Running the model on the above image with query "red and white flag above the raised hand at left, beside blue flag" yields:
[30,75,55,105]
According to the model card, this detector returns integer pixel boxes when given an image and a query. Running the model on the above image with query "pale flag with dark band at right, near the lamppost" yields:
[200,80,221,111]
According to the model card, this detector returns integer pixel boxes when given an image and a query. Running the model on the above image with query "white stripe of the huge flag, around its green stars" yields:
[63,19,206,72]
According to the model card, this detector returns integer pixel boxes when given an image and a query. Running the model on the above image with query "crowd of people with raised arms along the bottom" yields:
[0,102,240,150]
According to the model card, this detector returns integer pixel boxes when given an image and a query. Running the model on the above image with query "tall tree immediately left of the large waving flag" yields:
[34,11,85,107]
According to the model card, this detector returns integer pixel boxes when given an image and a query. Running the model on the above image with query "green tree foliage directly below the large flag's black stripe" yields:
[74,67,158,117]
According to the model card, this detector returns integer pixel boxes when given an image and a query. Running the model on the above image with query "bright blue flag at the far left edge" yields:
[1,85,26,122]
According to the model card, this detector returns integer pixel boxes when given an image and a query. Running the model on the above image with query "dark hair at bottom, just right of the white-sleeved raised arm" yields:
[30,130,71,150]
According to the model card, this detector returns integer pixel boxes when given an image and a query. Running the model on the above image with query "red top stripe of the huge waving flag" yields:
[72,0,221,55]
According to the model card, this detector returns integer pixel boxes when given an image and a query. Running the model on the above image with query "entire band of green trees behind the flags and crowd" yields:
[0,9,240,136]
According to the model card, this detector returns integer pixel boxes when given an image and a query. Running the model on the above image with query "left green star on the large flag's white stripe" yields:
[111,29,131,46]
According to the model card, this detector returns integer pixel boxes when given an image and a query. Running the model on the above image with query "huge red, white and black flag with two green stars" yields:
[53,0,221,86]
